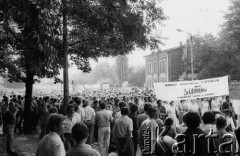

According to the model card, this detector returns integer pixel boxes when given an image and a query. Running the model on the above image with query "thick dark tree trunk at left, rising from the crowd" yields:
[23,70,34,134]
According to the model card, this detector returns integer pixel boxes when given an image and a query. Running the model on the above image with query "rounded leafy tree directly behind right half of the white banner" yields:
[190,34,240,79]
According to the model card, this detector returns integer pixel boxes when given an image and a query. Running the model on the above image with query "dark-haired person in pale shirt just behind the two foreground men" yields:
[64,104,81,147]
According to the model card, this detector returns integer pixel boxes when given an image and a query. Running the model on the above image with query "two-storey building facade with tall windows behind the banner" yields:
[145,45,185,89]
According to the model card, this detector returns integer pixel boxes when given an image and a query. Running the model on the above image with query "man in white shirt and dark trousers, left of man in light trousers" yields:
[83,100,96,145]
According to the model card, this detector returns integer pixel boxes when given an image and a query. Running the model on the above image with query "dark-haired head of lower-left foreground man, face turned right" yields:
[48,114,65,135]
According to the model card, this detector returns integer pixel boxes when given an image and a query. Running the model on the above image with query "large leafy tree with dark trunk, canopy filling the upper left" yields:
[0,0,166,132]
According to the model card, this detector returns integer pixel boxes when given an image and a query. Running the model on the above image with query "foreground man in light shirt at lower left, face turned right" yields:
[36,114,66,156]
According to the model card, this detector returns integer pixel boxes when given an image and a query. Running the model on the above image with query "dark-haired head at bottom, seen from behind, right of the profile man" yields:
[72,123,89,143]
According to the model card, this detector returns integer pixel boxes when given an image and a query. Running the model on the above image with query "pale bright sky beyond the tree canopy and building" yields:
[88,0,230,67]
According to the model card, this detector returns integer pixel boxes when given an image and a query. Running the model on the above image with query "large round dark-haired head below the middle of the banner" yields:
[186,112,201,129]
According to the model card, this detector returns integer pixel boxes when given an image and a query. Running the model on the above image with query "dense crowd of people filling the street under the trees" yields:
[0,88,240,156]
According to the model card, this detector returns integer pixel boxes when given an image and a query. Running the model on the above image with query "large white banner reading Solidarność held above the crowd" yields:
[154,76,229,101]
